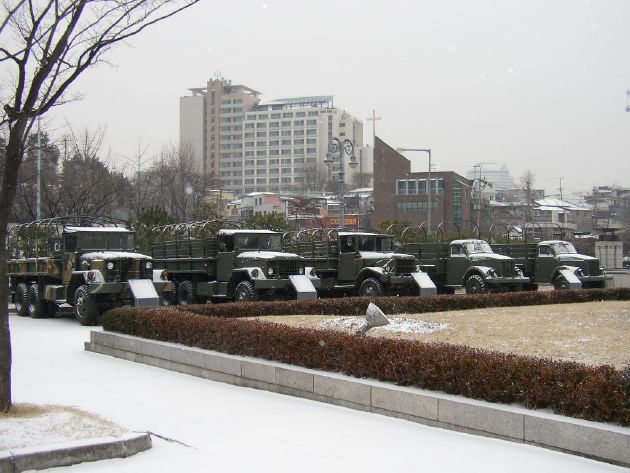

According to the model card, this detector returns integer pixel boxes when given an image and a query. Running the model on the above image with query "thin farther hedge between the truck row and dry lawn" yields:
[172,288,630,318]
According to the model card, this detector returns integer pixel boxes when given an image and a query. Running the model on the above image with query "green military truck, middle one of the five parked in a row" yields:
[287,230,436,296]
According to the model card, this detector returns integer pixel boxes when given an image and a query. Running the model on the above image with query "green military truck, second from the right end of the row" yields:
[402,235,530,294]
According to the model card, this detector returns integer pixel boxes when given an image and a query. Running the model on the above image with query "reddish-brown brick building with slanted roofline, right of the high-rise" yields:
[373,137,472,231]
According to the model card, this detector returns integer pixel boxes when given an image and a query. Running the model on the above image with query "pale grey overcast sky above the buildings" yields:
[47,0,630,196]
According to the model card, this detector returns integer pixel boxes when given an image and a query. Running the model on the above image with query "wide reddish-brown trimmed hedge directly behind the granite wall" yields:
[103,301,630,425]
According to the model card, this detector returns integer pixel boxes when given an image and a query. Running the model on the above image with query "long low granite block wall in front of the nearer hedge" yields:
[85,332,630,466]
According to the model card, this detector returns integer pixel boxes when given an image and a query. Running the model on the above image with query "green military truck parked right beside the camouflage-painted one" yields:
[151,221,317,304]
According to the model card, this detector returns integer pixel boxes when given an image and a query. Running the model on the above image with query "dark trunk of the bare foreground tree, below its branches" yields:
[0,118,28,412]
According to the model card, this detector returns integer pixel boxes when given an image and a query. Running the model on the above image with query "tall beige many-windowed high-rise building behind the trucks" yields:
[180,79,372,194]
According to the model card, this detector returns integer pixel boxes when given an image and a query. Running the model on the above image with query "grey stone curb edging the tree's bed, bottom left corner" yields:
[0,432,151,473]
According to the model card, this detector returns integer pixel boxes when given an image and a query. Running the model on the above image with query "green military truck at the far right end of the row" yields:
[492,240,606,289]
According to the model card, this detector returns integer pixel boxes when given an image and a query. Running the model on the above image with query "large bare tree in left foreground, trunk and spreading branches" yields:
[0,0,199,412]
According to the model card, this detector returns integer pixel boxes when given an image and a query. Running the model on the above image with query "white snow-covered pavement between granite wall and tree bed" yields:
[10,315,628,473]
